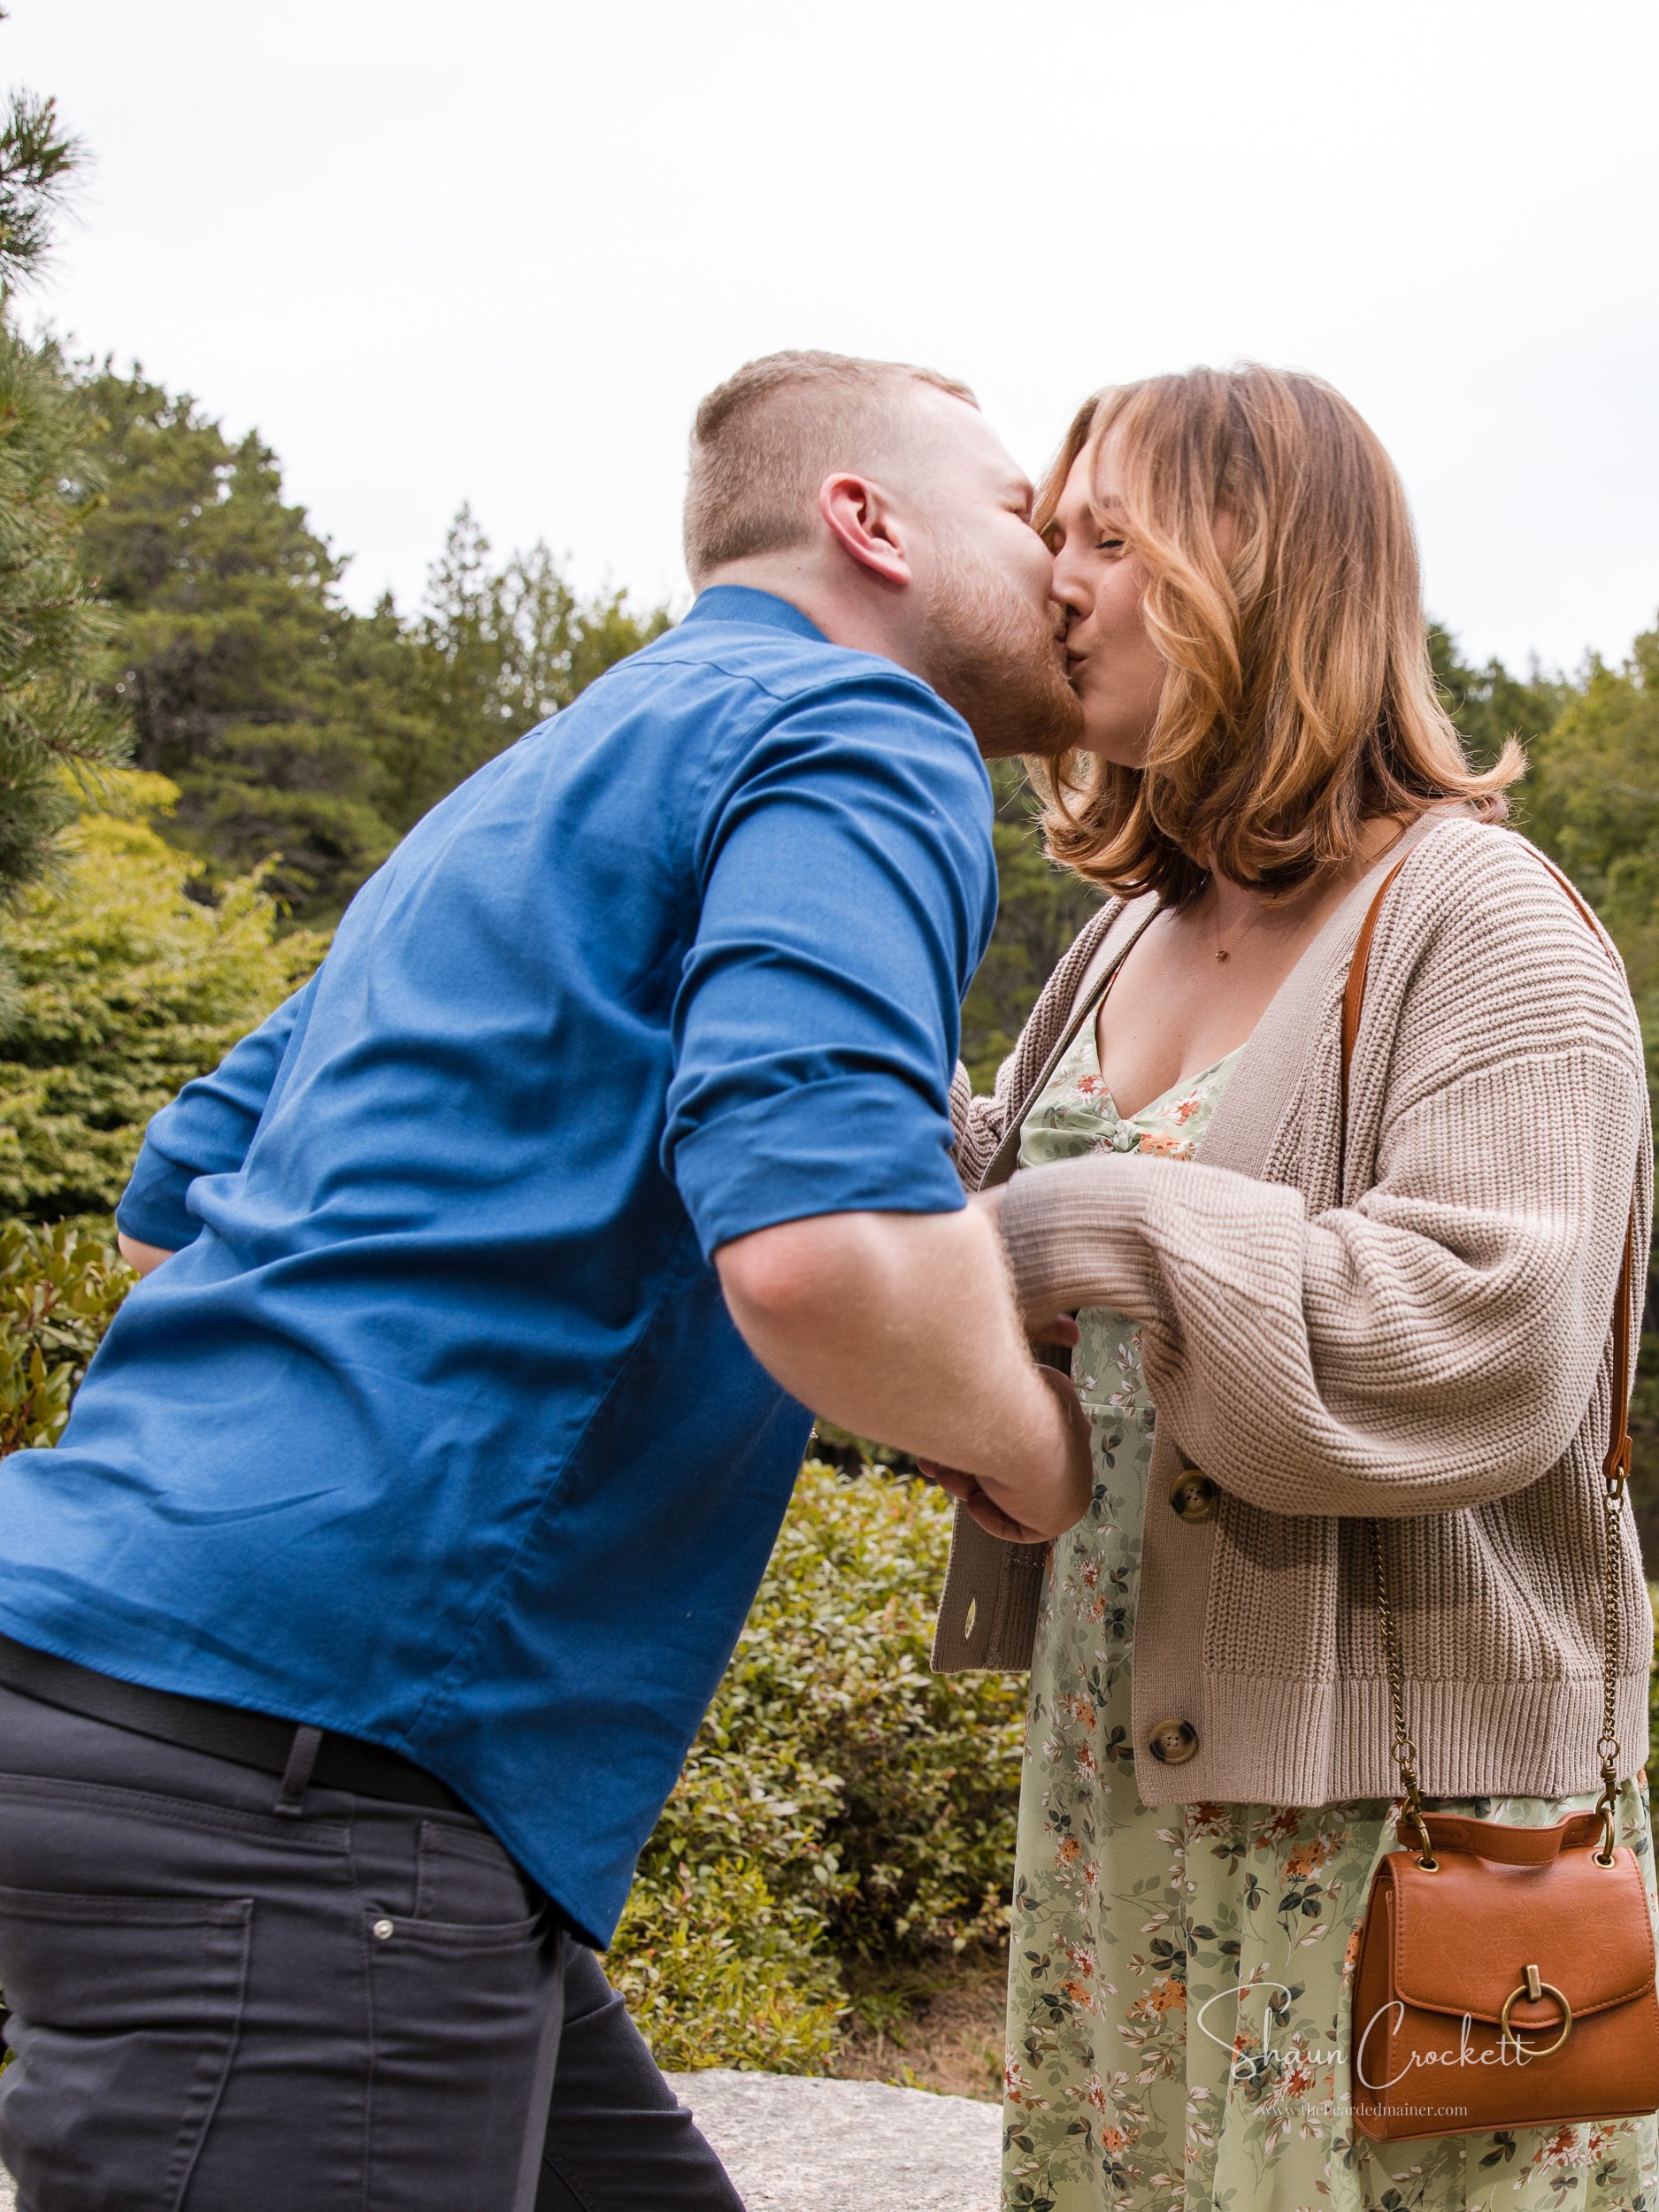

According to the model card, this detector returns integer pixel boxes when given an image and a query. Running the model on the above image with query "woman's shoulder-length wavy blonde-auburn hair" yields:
[1026,363,1526,905]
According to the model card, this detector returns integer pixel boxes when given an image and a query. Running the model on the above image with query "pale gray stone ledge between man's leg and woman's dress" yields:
[668,2069,1002,2212]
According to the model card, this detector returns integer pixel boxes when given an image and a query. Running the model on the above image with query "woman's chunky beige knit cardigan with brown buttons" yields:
[933,810,1653,1805]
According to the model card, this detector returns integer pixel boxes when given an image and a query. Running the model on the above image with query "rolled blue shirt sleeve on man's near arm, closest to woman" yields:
[664,671,995,1255]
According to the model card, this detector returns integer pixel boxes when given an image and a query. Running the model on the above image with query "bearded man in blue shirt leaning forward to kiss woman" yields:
[0,354,1088,2212]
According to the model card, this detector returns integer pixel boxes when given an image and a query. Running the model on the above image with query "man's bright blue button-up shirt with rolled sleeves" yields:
[0,587,995,1942]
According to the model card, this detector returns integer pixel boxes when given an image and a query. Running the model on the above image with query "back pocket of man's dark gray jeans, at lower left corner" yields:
[0,1889,255,2212]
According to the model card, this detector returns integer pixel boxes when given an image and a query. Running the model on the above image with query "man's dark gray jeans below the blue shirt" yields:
[0,1688,743,2212]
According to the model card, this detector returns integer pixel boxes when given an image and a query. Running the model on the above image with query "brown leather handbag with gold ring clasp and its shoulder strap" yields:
[1343,845,1659,2141]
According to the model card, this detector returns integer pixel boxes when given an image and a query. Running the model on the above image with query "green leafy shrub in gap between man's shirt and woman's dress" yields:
[609,1460,1025,2073]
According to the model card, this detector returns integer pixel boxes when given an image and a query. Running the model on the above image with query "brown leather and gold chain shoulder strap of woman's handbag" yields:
[1336,854,1637,1874]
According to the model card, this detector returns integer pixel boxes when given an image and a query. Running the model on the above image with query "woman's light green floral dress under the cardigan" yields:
[1002,1022,1659,2212]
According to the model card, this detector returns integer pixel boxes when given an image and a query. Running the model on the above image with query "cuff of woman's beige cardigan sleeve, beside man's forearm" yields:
[1002,1153,1168,1321]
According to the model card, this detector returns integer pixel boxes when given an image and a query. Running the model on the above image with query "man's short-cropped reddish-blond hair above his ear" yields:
[686,352,980,584]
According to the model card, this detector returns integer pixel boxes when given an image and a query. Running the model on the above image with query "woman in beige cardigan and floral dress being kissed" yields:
[936,367,1659,2212]
